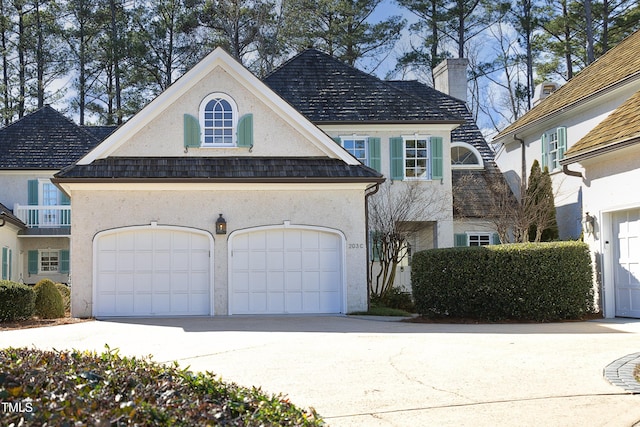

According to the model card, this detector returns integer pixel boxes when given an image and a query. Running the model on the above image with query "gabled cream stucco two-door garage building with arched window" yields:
[53,49,384,317]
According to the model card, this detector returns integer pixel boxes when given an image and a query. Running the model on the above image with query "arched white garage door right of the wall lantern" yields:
[229,228,343,314]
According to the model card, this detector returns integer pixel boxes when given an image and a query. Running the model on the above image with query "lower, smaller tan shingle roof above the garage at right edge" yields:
[562,91,640,163]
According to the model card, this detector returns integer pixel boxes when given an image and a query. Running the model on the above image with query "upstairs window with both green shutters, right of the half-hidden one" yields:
[389,135,443,180]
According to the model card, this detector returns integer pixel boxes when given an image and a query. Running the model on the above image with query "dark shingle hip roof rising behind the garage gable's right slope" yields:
[264,49,460,124]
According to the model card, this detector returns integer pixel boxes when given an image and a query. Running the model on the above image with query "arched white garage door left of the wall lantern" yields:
[94,227,211,316]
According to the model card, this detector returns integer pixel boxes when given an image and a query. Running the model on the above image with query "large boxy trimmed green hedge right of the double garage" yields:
[411,242,594,321]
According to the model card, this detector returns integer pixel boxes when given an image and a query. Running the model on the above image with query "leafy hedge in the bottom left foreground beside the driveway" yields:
[0,348,323,426]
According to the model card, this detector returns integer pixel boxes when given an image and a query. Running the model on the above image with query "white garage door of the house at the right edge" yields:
[612,209,640,318]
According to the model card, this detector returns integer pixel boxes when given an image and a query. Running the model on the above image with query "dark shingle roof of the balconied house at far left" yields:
[0,105,105,169]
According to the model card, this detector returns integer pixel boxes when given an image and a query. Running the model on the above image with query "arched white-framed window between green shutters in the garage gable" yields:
[200,93,238,147]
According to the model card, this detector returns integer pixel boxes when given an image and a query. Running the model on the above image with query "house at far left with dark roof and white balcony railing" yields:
[0,106,113,284]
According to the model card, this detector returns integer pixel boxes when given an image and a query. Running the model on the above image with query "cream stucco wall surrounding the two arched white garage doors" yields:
[71,186,367,317]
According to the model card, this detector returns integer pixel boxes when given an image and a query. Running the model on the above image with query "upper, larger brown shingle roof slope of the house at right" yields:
[496,31,640,139]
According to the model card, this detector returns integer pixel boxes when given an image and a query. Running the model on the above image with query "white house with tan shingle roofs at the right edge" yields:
[496,32,640,317]
